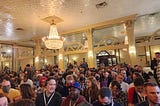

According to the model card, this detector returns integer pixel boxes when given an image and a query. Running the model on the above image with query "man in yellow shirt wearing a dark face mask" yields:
[0,77,21,103]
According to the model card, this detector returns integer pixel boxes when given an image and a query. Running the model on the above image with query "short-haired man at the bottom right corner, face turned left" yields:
[136,82,160,106]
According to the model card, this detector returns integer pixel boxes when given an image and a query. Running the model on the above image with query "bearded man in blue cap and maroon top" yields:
[61,82,90,106]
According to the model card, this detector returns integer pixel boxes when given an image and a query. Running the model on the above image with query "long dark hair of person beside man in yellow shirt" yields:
[20,84,35,99]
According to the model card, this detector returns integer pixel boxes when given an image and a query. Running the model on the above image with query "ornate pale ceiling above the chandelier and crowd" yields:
[0,0,160,41]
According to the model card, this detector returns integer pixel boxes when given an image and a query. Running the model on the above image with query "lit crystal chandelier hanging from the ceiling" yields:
[42,16,64,49]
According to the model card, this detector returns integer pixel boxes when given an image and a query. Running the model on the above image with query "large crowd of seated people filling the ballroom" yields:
[0,62,160,106]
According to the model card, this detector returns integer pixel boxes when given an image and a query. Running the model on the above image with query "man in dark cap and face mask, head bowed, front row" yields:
[93,87,121,106]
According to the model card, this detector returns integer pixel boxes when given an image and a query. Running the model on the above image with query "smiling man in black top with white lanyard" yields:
[35,77,62,106]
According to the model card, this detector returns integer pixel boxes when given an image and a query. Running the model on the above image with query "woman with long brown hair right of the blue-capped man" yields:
[82,76,98,103]
